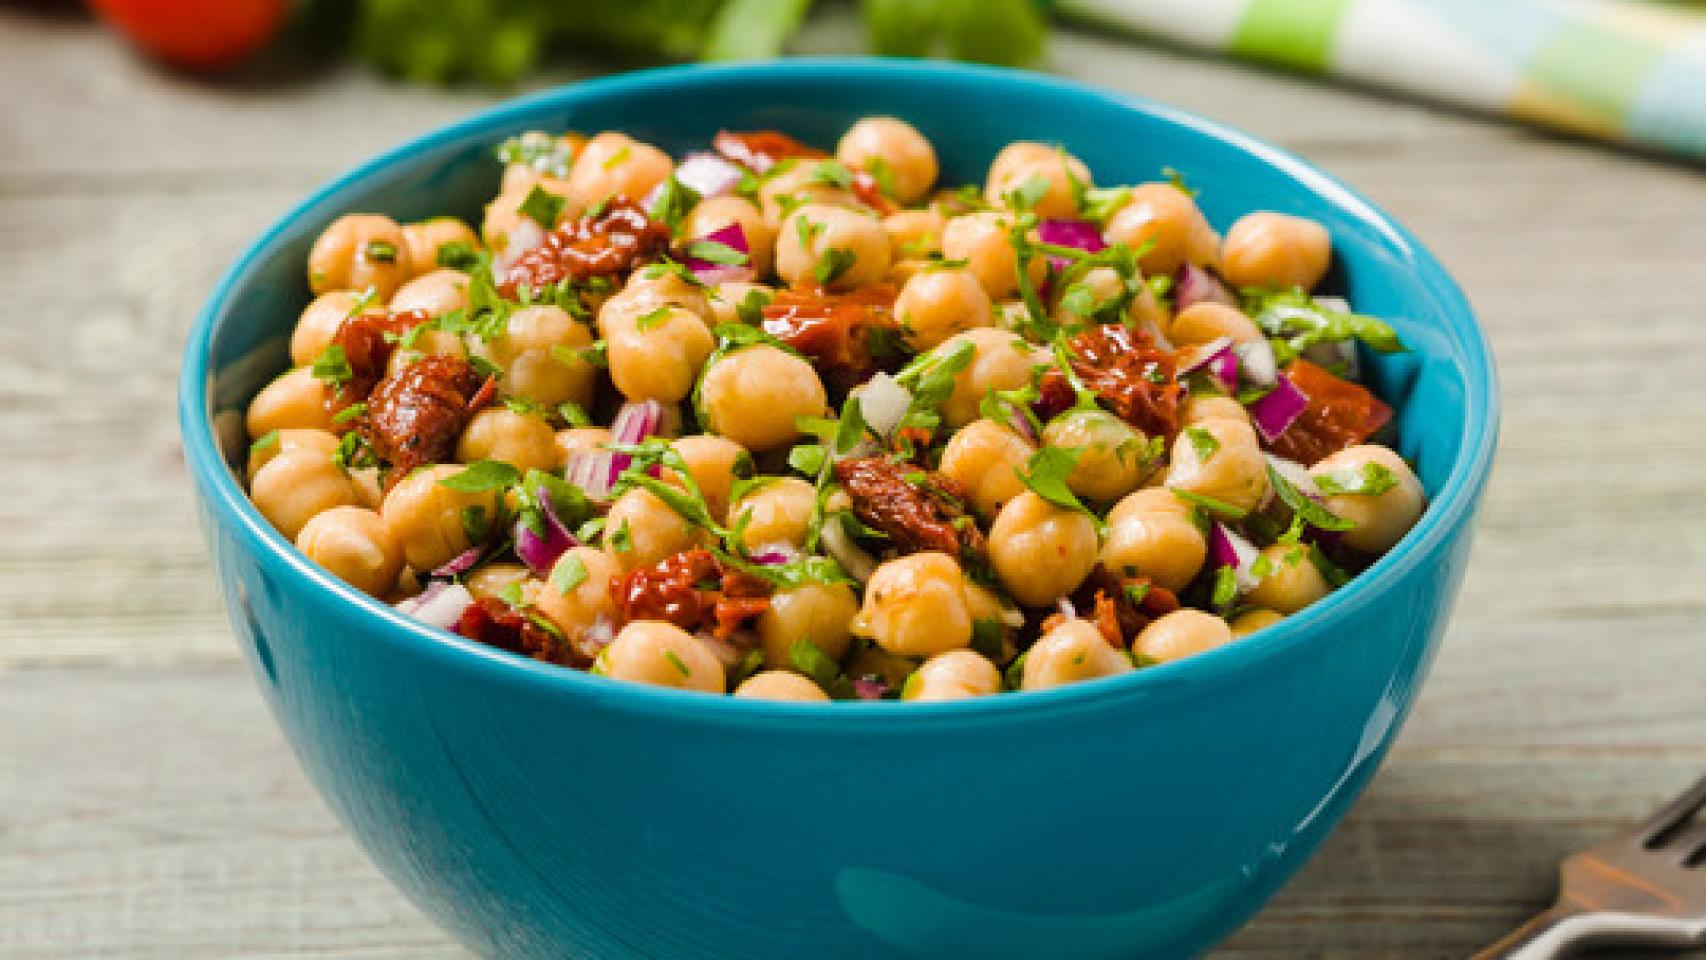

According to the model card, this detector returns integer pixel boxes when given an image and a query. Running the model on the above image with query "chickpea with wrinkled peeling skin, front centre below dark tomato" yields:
[853,551,971,656]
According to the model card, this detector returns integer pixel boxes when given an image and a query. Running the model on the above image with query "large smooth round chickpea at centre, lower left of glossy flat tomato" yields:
[699,343,829,452]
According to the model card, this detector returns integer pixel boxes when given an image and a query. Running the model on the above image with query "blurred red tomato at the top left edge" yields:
[89,0,288,70]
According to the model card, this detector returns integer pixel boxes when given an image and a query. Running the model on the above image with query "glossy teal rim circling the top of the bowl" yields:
[177,58,1500,728]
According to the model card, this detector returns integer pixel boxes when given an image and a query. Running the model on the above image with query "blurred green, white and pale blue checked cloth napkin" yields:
[1056,0,1706,160]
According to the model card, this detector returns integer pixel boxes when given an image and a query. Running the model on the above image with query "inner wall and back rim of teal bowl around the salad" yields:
[183,60,1496,706]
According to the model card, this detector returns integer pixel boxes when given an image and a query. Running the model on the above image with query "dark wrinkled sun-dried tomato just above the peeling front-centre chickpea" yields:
[836,457,983,558]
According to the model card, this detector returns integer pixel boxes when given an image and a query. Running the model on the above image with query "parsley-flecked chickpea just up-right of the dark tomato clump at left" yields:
[474,304,599,409]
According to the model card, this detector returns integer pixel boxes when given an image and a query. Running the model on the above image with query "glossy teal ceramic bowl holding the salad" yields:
[181,60,1498,960]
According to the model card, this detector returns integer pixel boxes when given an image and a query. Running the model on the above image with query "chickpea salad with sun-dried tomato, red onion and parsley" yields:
[247,118,1425,701]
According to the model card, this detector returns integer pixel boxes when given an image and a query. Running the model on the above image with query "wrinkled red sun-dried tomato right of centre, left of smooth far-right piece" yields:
[1039,324,1184,442]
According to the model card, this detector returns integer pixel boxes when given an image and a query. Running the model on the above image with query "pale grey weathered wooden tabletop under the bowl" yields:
[0,5,1706,960]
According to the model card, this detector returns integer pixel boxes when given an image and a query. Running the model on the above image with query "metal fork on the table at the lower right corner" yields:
[1472,778,1706,960]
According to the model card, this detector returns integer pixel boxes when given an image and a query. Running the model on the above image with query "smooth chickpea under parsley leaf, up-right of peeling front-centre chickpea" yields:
[989,489,1100,607]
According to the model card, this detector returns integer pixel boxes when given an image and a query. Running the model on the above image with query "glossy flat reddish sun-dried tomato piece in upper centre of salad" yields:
[761,285,897,389]
